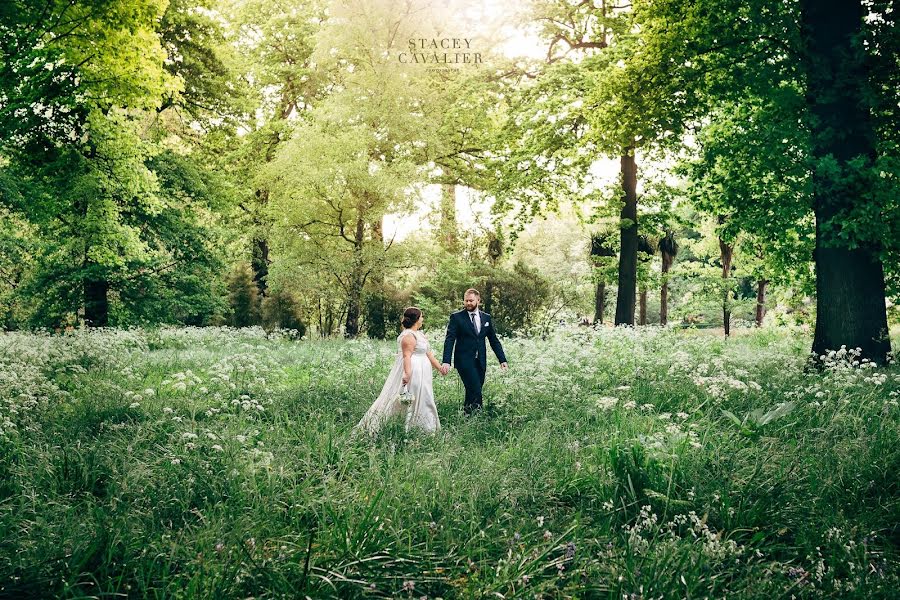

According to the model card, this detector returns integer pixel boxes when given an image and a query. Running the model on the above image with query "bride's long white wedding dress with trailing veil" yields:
[356,329,441,433]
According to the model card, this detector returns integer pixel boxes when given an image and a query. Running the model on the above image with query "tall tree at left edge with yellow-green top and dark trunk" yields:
[0,0,180,326]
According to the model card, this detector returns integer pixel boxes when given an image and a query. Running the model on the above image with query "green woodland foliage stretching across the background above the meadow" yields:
[0,0,900,338]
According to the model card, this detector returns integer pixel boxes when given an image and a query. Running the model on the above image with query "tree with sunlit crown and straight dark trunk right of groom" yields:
[498,1,691,324]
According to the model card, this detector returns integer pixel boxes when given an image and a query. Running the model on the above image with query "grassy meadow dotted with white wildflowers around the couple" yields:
[0,328,900,599]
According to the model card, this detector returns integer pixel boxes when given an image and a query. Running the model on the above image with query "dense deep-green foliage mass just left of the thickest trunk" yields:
[679,96,814,284]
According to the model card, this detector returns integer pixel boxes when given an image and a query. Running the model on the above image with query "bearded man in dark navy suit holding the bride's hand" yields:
[441,288,508,415]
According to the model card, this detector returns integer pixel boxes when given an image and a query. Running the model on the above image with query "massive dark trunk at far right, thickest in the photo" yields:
[800,0,891,363]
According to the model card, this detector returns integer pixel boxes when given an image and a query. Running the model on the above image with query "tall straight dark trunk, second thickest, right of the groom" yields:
[615,147,638,325]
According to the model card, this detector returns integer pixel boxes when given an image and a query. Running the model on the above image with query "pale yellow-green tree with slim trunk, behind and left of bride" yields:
[266,79,424,337]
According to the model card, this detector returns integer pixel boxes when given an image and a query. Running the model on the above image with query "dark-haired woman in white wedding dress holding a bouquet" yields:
[356,306,441,433]
